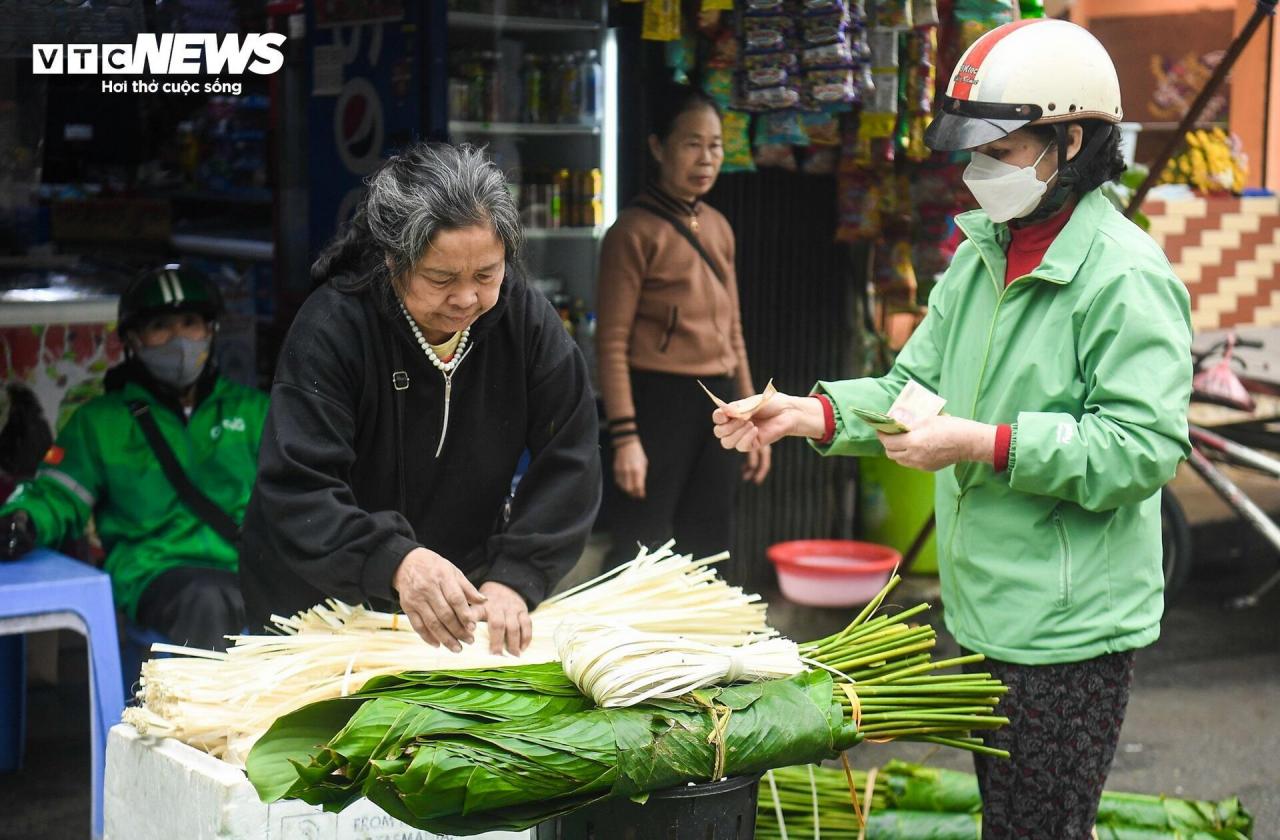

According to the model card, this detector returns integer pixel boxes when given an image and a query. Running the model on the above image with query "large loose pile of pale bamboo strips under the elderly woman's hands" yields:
[124,543,777,766]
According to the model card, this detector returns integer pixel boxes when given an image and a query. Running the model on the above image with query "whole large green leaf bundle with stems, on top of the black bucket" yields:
[246,578,1006,834]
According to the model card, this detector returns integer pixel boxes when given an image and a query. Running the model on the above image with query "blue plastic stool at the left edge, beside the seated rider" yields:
[0,549,124,837]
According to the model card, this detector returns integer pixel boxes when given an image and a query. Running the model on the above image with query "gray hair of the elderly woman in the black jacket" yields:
[312,142,524,296]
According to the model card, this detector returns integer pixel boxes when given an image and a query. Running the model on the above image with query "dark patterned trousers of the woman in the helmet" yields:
[965,650,1134,840]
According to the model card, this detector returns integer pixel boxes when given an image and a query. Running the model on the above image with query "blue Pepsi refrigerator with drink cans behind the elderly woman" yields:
[268,0,618,340]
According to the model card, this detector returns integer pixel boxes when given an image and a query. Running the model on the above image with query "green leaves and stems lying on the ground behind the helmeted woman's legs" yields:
[755,761,1253,840]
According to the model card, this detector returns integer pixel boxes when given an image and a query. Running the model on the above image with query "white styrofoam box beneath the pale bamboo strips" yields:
[102,723,534,840]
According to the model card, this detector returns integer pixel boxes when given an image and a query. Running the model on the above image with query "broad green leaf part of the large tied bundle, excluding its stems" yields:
[247,665,860,834]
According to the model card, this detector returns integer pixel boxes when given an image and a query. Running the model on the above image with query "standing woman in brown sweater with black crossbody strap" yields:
[596,85,769,567]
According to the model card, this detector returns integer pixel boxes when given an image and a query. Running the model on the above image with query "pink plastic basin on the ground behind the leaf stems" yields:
[767,539,902,607]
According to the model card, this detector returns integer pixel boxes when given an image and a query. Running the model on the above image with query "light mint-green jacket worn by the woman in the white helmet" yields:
[817,190,1192,665]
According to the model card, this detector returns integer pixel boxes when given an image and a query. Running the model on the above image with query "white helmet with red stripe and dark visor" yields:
[924,19,1124,151]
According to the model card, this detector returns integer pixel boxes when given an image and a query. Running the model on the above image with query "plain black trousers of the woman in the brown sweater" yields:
[604,370,742,569]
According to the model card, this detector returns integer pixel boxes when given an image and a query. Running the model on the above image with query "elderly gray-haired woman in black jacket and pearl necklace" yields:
[241,143,600,654]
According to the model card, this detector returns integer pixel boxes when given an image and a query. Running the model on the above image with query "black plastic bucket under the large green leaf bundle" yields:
[536,776,760,840]
